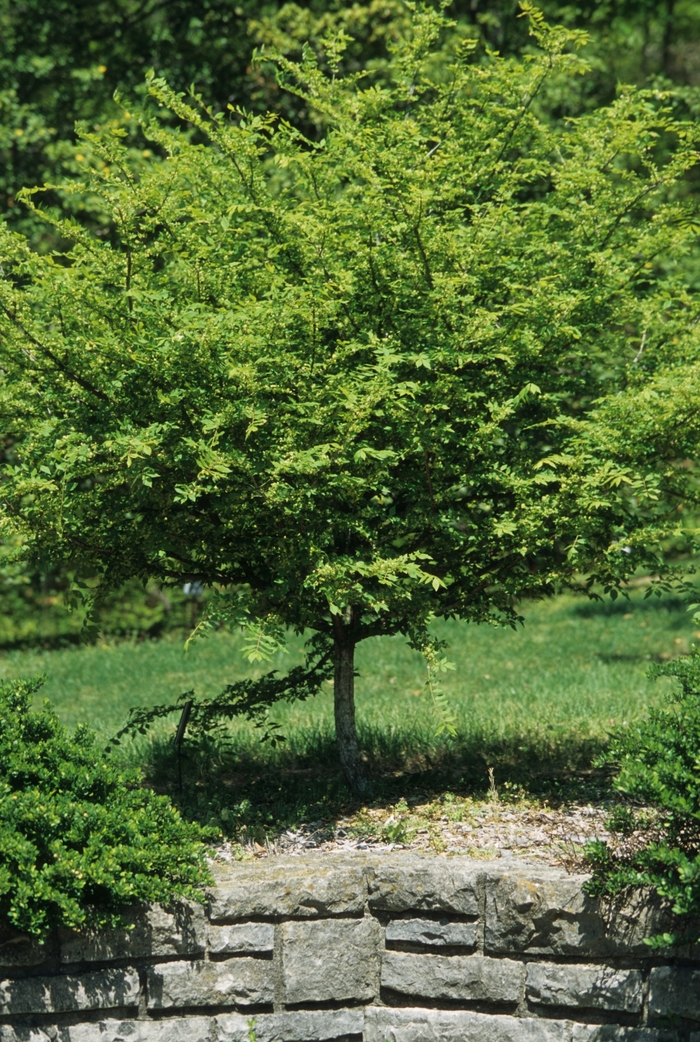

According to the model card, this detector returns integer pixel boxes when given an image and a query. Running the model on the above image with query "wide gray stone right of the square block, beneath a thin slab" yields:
[381,951,525,1002]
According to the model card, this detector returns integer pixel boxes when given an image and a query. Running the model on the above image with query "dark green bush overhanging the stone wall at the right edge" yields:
[588,647,700,945]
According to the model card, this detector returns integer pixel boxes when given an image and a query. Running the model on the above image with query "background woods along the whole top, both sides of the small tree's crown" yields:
[0,0,700,237]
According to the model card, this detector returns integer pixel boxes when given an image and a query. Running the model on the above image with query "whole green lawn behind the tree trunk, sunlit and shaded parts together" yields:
[0,594,694,827]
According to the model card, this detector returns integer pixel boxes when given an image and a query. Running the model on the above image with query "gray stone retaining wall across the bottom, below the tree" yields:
[0,852,700,1042]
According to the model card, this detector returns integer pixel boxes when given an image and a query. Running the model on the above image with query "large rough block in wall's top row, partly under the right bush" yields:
[484,869,673,958]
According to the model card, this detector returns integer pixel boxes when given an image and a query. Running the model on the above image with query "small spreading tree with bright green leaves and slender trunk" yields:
[0,10,697,793]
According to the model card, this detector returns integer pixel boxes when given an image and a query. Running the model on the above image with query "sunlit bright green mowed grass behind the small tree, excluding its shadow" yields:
[0,595,694,783]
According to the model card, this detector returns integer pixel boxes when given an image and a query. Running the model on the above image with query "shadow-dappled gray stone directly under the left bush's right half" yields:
[60,902,206,963]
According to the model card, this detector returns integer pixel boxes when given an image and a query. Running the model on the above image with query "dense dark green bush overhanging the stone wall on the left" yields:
[0,678,210,938]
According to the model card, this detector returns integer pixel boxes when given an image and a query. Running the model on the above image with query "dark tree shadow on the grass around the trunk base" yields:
[138,729,609,842]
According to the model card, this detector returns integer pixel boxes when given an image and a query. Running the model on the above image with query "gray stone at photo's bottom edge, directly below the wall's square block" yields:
[217,1010,365,1042]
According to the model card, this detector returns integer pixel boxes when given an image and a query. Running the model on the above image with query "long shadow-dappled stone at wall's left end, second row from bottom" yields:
[0,968,140,1015]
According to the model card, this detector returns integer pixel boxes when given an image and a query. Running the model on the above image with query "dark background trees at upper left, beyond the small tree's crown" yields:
[0,0,405,234]
